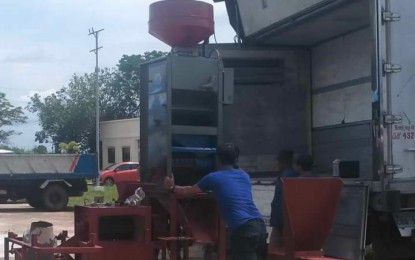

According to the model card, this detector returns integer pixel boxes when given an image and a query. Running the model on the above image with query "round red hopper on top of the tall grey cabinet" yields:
[148,0,214,48]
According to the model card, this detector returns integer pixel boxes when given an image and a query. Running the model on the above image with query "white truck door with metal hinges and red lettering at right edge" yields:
[377,0,415,182]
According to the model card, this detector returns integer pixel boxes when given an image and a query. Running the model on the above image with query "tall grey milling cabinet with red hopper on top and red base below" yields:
[136,0,226,260]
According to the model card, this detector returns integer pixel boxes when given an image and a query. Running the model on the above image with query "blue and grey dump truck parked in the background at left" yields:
[0,154,98,211]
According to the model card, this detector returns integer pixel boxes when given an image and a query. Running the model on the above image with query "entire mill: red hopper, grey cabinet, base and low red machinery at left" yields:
[5,0,226,260]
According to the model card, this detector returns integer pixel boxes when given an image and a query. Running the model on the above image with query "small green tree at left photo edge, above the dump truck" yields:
[0,92,27,144]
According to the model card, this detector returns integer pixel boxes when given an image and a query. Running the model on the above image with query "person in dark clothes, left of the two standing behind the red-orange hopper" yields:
[270,150,298,247]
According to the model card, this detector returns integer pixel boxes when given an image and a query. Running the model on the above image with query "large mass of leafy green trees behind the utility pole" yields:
[27,51,166,152]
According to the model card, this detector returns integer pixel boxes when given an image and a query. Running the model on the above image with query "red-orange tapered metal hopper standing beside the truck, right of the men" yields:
[268,178,343,259]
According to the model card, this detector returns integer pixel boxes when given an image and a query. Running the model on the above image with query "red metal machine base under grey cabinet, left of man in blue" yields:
[117,182,227,260]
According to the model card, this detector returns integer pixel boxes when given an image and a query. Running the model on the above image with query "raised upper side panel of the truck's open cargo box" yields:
[228,0,370,46]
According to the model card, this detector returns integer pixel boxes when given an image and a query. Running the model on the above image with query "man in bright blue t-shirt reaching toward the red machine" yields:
[164,143,267,260]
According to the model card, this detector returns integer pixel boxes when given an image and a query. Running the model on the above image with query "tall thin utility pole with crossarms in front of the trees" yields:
[88,28,104,186]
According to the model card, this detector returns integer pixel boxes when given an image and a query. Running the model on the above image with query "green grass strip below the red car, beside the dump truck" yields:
[68,185,118,207]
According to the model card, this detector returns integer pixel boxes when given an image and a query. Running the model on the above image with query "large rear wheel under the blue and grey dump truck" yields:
[42,184,69,211]
